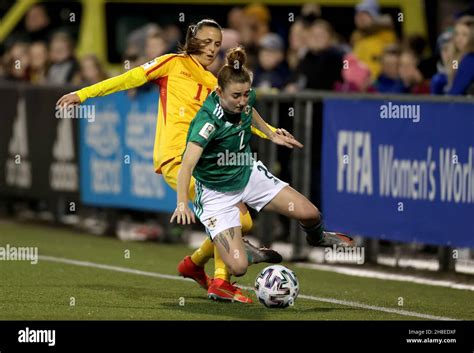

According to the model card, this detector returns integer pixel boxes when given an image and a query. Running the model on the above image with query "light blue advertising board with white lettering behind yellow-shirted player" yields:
[80,89,176,212]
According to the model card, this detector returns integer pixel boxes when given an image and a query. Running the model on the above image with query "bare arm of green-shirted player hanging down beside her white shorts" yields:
[170,142,203,224]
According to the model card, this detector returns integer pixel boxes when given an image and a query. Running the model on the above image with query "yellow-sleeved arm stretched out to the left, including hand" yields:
[56,66,148,107]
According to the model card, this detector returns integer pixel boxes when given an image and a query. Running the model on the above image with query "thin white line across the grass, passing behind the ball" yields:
[38,255,457,320]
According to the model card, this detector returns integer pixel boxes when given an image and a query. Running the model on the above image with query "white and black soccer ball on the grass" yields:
[255,265,300,308]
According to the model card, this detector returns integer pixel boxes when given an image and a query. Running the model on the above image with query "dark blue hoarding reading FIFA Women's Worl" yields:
[322,99,474,247]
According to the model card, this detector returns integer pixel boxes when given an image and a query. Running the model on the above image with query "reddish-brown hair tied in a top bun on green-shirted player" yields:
[217,47,253,90]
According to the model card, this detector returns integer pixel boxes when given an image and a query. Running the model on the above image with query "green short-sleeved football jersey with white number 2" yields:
[186,90,256,192]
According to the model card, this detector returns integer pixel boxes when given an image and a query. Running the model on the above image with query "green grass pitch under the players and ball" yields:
[0,222,474,320]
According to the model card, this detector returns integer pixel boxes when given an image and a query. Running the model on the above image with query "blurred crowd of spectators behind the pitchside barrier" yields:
[0,0,474,95]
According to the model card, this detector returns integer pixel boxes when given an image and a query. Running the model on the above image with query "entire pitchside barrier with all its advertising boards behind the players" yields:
[0,84,474,259]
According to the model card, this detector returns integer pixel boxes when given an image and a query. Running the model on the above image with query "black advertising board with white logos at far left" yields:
[0,84,79,212]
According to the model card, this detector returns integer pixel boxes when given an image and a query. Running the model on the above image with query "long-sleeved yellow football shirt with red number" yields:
[76,54,275,173]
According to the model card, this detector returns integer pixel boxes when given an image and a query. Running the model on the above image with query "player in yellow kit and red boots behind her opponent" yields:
[57,19,302,303]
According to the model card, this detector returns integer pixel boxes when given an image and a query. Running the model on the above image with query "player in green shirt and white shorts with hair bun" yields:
[170,48,354,300]
